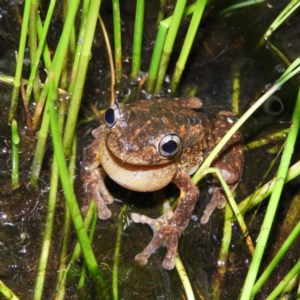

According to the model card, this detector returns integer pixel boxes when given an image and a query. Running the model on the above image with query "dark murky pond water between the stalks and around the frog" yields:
[0,0,300,299]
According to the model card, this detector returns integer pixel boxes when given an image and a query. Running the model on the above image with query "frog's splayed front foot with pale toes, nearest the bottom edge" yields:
[131,213,184,270]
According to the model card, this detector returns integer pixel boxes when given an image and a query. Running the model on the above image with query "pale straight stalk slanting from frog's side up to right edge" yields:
[193,58,300,182]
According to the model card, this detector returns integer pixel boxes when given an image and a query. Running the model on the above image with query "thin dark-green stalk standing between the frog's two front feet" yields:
[112,205,127,300]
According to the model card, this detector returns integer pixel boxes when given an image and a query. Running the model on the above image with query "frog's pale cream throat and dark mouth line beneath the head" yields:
[100,139,176,192]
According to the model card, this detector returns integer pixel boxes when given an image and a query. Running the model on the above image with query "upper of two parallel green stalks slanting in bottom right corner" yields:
[252,222,300,297]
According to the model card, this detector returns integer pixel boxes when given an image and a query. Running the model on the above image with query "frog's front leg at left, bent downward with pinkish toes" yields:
[80,127,114,220]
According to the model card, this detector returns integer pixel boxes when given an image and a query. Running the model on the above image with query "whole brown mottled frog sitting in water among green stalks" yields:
[81,97,244,270]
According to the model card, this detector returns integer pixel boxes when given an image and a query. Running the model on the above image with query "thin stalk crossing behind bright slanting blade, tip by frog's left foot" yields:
[55,201,97,300]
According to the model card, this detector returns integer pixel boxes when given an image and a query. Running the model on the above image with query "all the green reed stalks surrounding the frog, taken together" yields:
[0,0,300,300]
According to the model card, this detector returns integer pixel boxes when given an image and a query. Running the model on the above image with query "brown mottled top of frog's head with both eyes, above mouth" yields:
[104,100,184,165]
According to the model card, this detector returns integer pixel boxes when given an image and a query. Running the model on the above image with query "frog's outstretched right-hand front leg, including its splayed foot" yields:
[131,171,199,270]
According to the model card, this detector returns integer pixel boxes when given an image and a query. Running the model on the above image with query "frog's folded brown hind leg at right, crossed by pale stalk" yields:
[201,111,244,224]
